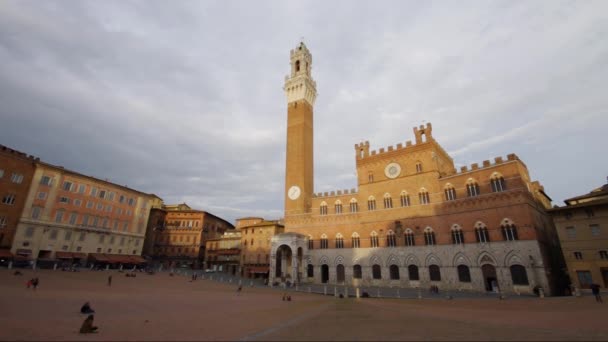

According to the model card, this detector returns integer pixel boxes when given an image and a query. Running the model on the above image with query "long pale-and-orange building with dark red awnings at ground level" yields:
[11,161,162,264]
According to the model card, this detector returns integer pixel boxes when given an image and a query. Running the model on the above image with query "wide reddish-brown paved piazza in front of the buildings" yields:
[0,269,608,341]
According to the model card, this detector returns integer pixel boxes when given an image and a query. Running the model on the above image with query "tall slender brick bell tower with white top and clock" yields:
[283,43,317,217]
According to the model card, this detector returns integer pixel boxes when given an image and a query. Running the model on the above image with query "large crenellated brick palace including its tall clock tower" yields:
[270,43,563,294]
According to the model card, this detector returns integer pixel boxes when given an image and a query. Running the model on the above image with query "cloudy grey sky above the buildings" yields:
[0,0,608,222]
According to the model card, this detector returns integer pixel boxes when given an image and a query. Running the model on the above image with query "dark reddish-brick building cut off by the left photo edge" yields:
[0,145,38,262]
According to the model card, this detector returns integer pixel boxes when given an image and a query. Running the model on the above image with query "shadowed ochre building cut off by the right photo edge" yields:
[550,180,608,289]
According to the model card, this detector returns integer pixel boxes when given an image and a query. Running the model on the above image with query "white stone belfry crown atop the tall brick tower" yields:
[283,42,317,106]
